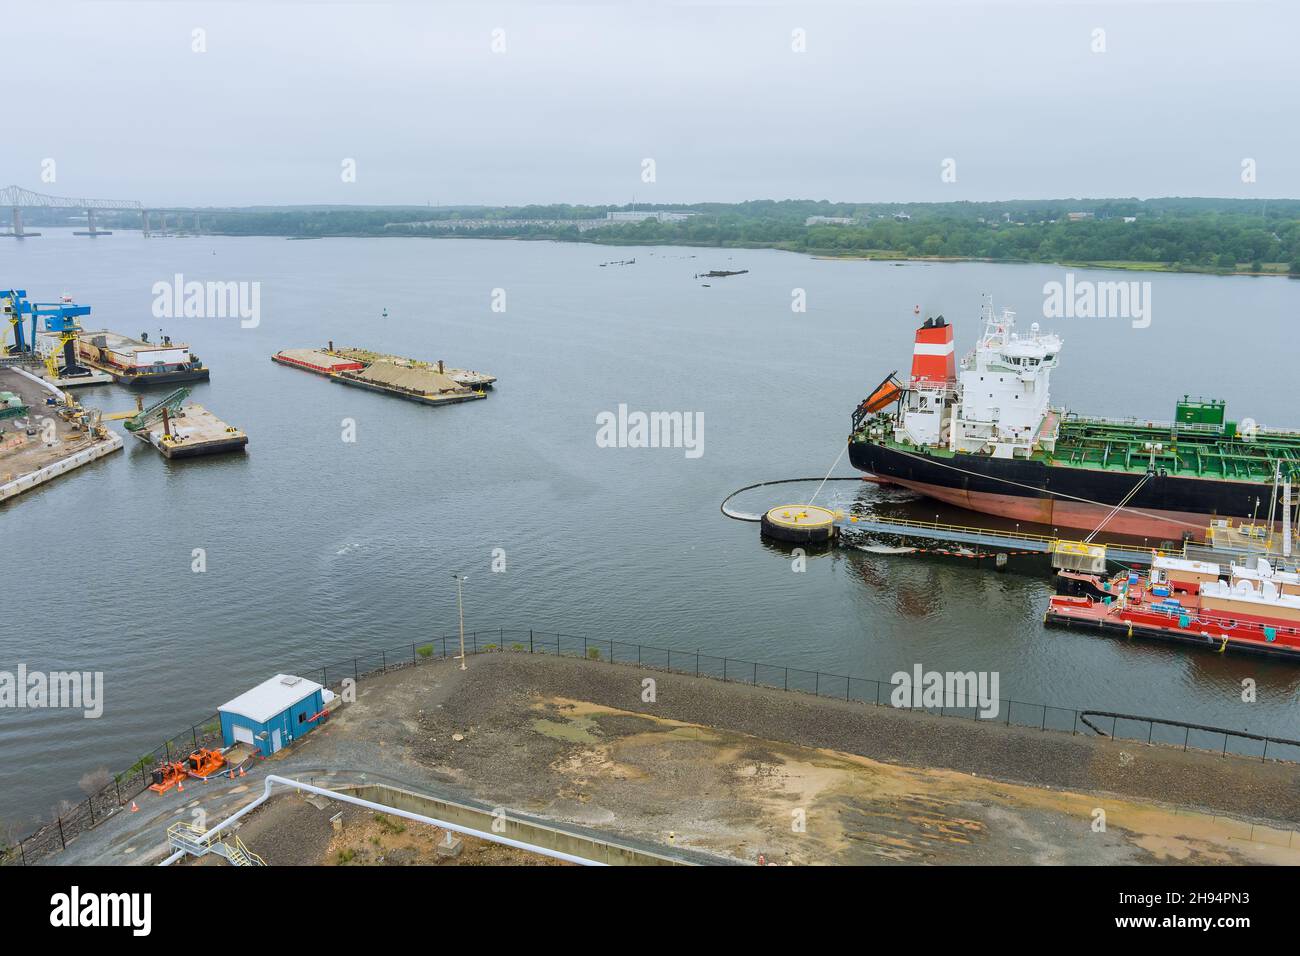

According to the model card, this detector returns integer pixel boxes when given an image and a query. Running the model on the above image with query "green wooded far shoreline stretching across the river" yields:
[104,199,1300,276]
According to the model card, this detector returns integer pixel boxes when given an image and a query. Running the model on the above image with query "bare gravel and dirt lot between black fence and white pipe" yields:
[51,652,1300,864]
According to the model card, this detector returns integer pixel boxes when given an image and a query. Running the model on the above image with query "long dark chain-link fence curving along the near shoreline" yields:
[0,628,1300,865]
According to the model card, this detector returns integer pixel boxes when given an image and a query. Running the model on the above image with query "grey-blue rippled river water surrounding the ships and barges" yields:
[0,229,1300,830]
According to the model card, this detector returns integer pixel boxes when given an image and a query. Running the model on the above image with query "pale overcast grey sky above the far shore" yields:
[0,0,1300,206]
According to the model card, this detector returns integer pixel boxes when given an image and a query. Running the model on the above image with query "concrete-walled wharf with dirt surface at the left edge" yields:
[0,367,122,502]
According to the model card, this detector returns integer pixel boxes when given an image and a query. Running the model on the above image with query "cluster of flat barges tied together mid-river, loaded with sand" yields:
[270,342,497,405]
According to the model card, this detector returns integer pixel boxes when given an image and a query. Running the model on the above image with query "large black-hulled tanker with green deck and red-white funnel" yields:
[849,302,1300,541]
